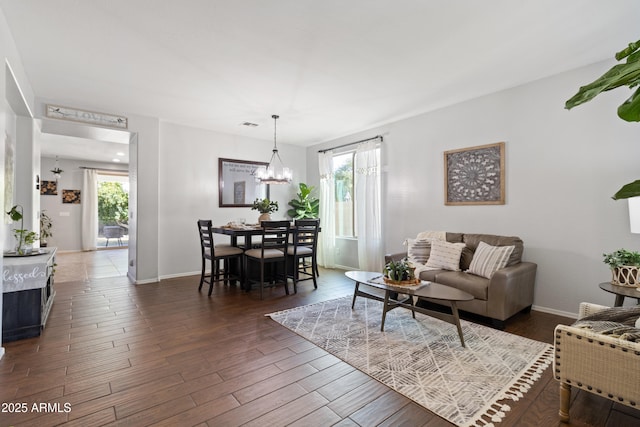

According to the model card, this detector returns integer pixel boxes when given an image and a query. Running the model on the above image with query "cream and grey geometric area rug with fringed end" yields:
[267,296,553,427]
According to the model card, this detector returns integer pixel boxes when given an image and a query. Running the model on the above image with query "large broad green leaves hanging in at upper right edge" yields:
[565,40,640,200]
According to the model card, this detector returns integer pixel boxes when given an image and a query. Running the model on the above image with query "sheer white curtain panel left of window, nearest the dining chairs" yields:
[318,151,336,268]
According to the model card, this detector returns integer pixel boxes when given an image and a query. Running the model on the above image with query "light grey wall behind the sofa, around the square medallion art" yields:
[307,61,640,313]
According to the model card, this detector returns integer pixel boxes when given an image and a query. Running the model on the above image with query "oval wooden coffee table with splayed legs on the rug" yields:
[344,271,473,347]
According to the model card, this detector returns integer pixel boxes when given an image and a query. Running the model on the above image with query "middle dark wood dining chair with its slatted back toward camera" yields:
[244,221,290,299]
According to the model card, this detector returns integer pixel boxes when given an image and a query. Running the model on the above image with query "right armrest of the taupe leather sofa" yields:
[487,262,538,320]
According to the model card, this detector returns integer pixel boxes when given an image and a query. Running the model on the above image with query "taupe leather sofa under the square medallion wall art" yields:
[385,232,537,329]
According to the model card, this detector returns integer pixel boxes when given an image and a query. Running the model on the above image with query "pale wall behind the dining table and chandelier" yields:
[158,123,306,278]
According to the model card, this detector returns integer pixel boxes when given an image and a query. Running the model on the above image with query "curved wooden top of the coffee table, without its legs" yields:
[344,271,473,301]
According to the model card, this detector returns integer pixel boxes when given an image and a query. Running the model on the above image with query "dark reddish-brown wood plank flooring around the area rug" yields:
[0,270,640,427]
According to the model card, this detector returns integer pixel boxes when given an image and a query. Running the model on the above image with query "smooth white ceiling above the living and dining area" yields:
[0,0,640,161]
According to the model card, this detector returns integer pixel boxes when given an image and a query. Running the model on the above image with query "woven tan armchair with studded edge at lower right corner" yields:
[553,303,640,422]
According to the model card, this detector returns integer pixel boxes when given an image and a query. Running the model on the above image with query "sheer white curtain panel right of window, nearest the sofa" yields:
[355,140,384,271]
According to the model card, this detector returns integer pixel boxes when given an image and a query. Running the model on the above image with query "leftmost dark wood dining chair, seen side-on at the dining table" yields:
[198,219,244,296]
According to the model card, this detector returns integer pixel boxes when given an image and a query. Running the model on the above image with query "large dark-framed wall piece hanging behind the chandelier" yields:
[218,157,269,208]
